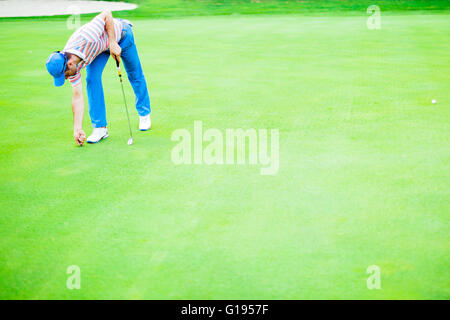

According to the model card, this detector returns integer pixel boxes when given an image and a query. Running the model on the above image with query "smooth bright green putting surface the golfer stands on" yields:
[0,4,450,299]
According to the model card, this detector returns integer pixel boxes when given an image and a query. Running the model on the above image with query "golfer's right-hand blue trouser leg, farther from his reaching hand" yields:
[119,26,151,116]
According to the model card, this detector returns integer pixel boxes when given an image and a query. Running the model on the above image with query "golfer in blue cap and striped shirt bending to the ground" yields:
[46,11,151,146]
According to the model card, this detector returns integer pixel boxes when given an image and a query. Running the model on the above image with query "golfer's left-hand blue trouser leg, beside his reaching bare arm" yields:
[86,51,109,128]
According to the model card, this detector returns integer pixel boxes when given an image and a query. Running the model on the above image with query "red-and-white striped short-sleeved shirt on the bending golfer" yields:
[63,16,122,87]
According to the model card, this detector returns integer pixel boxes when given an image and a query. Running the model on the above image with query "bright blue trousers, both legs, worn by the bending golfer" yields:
[86,22,151,128]
